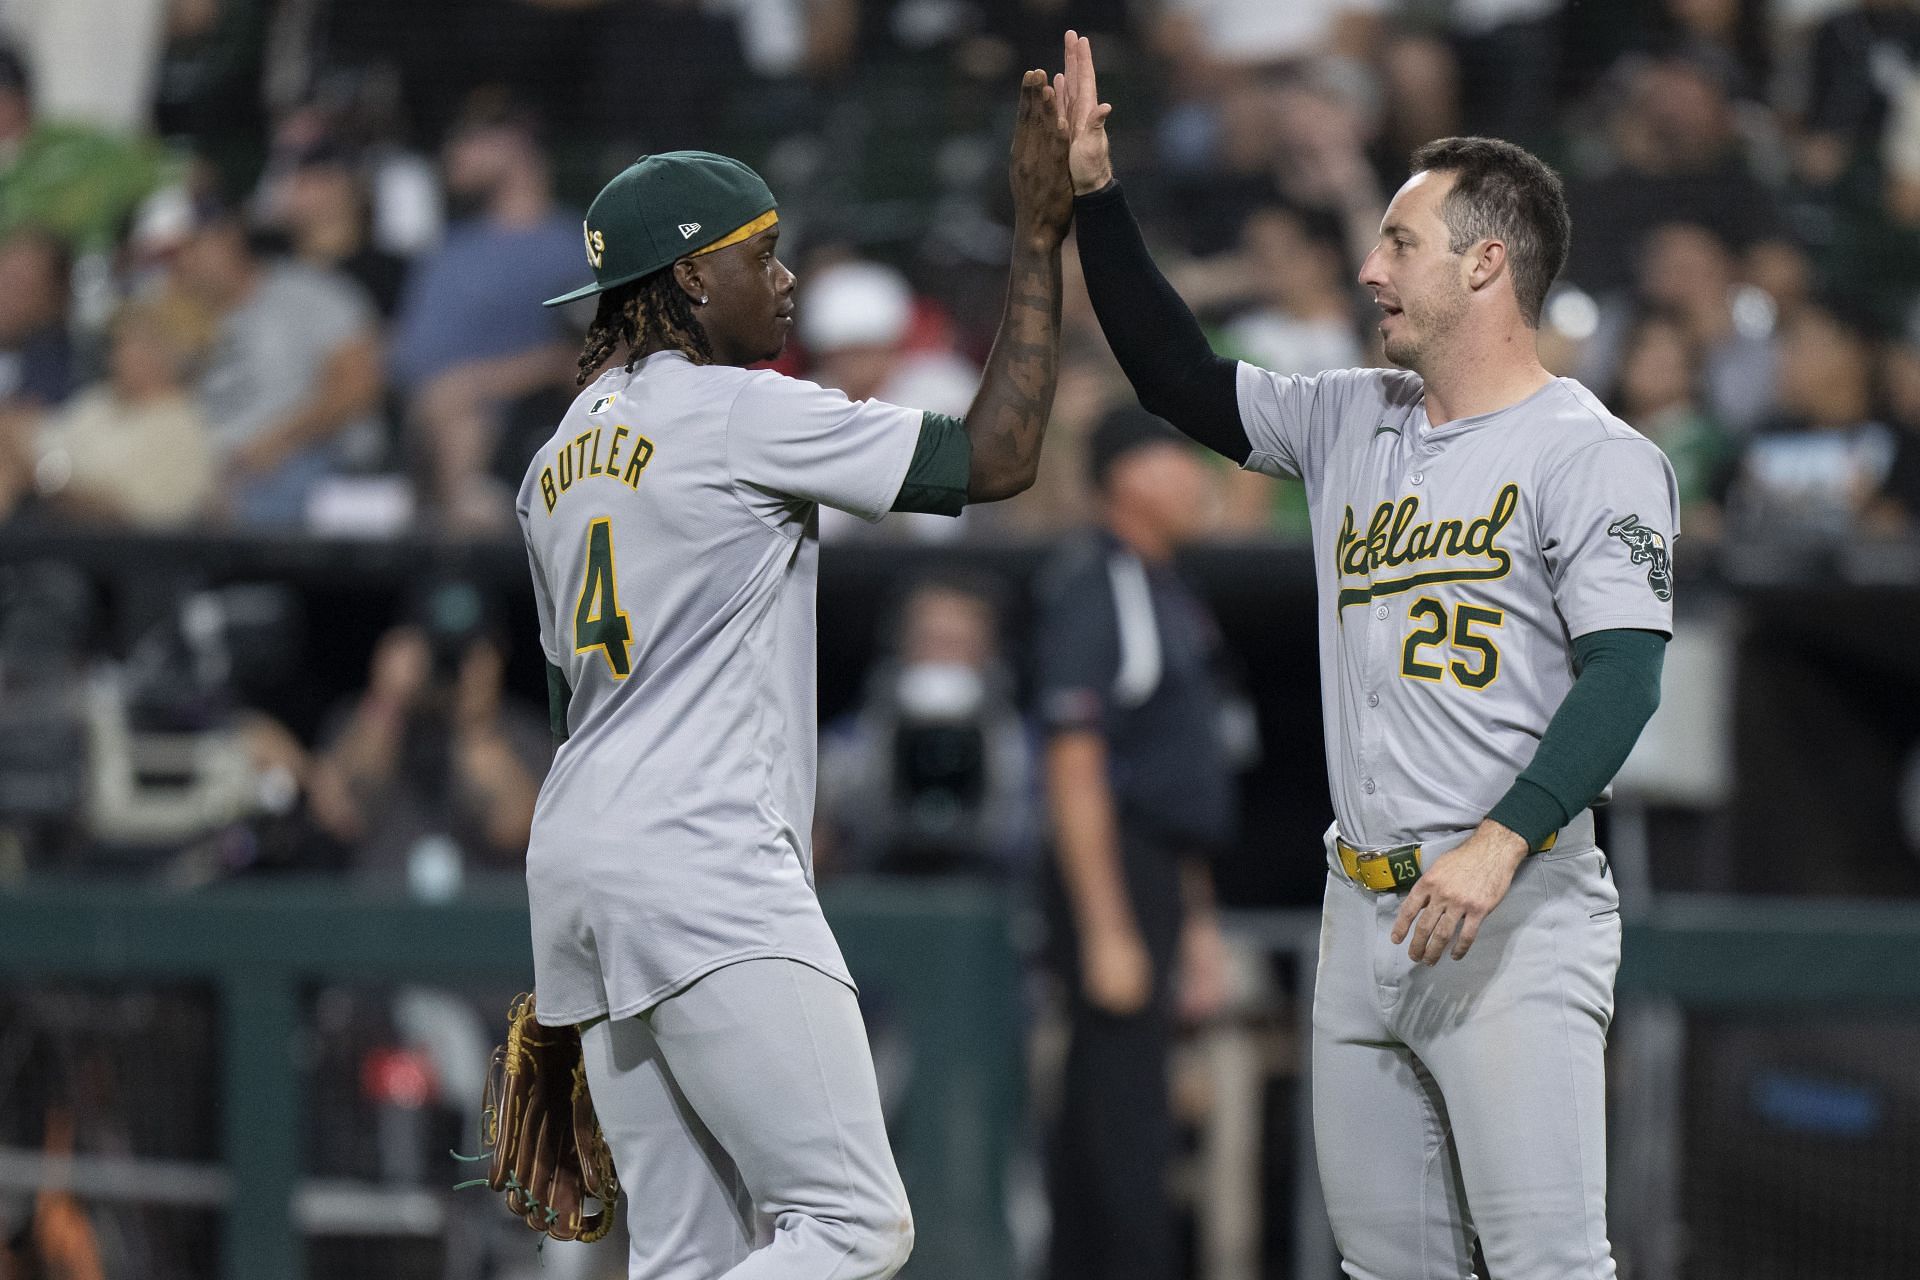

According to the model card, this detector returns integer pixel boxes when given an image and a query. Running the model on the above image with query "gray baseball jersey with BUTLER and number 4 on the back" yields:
[518,351,922,1025]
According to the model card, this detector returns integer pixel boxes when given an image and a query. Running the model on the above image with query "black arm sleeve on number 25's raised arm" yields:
[1073,182,1254,464]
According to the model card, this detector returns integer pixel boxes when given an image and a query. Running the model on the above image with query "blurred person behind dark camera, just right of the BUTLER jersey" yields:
[816,576,1039,877]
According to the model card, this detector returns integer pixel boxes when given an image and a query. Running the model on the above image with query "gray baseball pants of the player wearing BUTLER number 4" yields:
[582,960,914,1280]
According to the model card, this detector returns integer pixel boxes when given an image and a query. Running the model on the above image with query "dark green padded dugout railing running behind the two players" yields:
[0,883,1920,1280]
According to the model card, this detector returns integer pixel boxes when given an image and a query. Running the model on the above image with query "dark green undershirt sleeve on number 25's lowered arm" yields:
[1488,629,1667,848]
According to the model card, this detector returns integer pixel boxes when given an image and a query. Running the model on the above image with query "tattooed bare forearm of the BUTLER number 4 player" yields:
[966,246,1060,503]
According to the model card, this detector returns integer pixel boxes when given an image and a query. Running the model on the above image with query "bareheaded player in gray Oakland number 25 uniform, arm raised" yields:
[1056,33,1678,1280]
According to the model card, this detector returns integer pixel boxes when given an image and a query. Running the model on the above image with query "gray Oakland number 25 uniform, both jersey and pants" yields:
[1238,365,1678,1280]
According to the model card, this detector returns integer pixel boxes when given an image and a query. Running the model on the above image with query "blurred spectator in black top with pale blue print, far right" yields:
[1730,305,1895,539]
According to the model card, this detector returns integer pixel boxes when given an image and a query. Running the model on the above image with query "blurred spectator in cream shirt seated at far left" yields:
[1,296,215,528]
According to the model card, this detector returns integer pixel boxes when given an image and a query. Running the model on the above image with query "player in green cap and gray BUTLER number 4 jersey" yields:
[518,71,1071,1280]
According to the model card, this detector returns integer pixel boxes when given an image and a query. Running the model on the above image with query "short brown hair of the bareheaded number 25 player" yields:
[1413,138,1572,328]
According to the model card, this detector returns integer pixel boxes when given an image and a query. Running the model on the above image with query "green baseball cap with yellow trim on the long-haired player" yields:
[541,152,780,307]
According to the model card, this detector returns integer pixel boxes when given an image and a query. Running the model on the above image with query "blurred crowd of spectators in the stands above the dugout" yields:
[0,0,1920,539]
